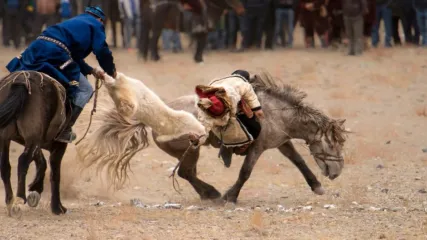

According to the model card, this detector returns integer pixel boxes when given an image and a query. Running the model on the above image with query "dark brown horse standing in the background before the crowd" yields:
[139,0,244,62]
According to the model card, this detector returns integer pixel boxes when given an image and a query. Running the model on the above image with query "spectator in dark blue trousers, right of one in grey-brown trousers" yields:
[372,0,393,47]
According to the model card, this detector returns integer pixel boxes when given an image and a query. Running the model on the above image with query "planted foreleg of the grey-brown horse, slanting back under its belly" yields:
[223,142,264,202]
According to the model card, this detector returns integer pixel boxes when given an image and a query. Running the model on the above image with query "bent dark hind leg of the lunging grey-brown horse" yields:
[178,149,221,200]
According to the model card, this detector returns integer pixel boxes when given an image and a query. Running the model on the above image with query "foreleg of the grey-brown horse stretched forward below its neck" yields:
[278,141,325,195]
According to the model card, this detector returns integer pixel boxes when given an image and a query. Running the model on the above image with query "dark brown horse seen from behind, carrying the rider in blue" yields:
[0,71,69,217]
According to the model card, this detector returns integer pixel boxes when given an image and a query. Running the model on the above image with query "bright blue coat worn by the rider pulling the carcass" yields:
[6,13,115,98]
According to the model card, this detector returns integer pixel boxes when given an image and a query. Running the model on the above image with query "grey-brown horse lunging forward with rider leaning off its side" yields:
[153,74,347,202]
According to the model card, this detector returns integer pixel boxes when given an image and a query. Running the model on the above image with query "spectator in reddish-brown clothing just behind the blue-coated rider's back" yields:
[33,0,60,36]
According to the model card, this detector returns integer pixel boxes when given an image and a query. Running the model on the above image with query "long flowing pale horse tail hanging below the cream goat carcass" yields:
[77,108,149,188]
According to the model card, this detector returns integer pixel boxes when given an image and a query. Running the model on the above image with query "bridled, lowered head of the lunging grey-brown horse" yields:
[307,120,346,179]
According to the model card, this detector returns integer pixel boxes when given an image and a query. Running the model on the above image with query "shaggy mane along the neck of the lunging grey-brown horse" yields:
[250,72,348,143]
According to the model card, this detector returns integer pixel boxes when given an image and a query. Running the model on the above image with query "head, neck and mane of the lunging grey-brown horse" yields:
[250,72,348,179]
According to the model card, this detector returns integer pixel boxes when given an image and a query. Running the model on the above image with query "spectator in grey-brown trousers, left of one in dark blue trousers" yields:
[342,0,368,55]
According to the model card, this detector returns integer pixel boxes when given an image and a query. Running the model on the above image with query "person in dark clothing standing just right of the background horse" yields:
[240,0,269,52]
